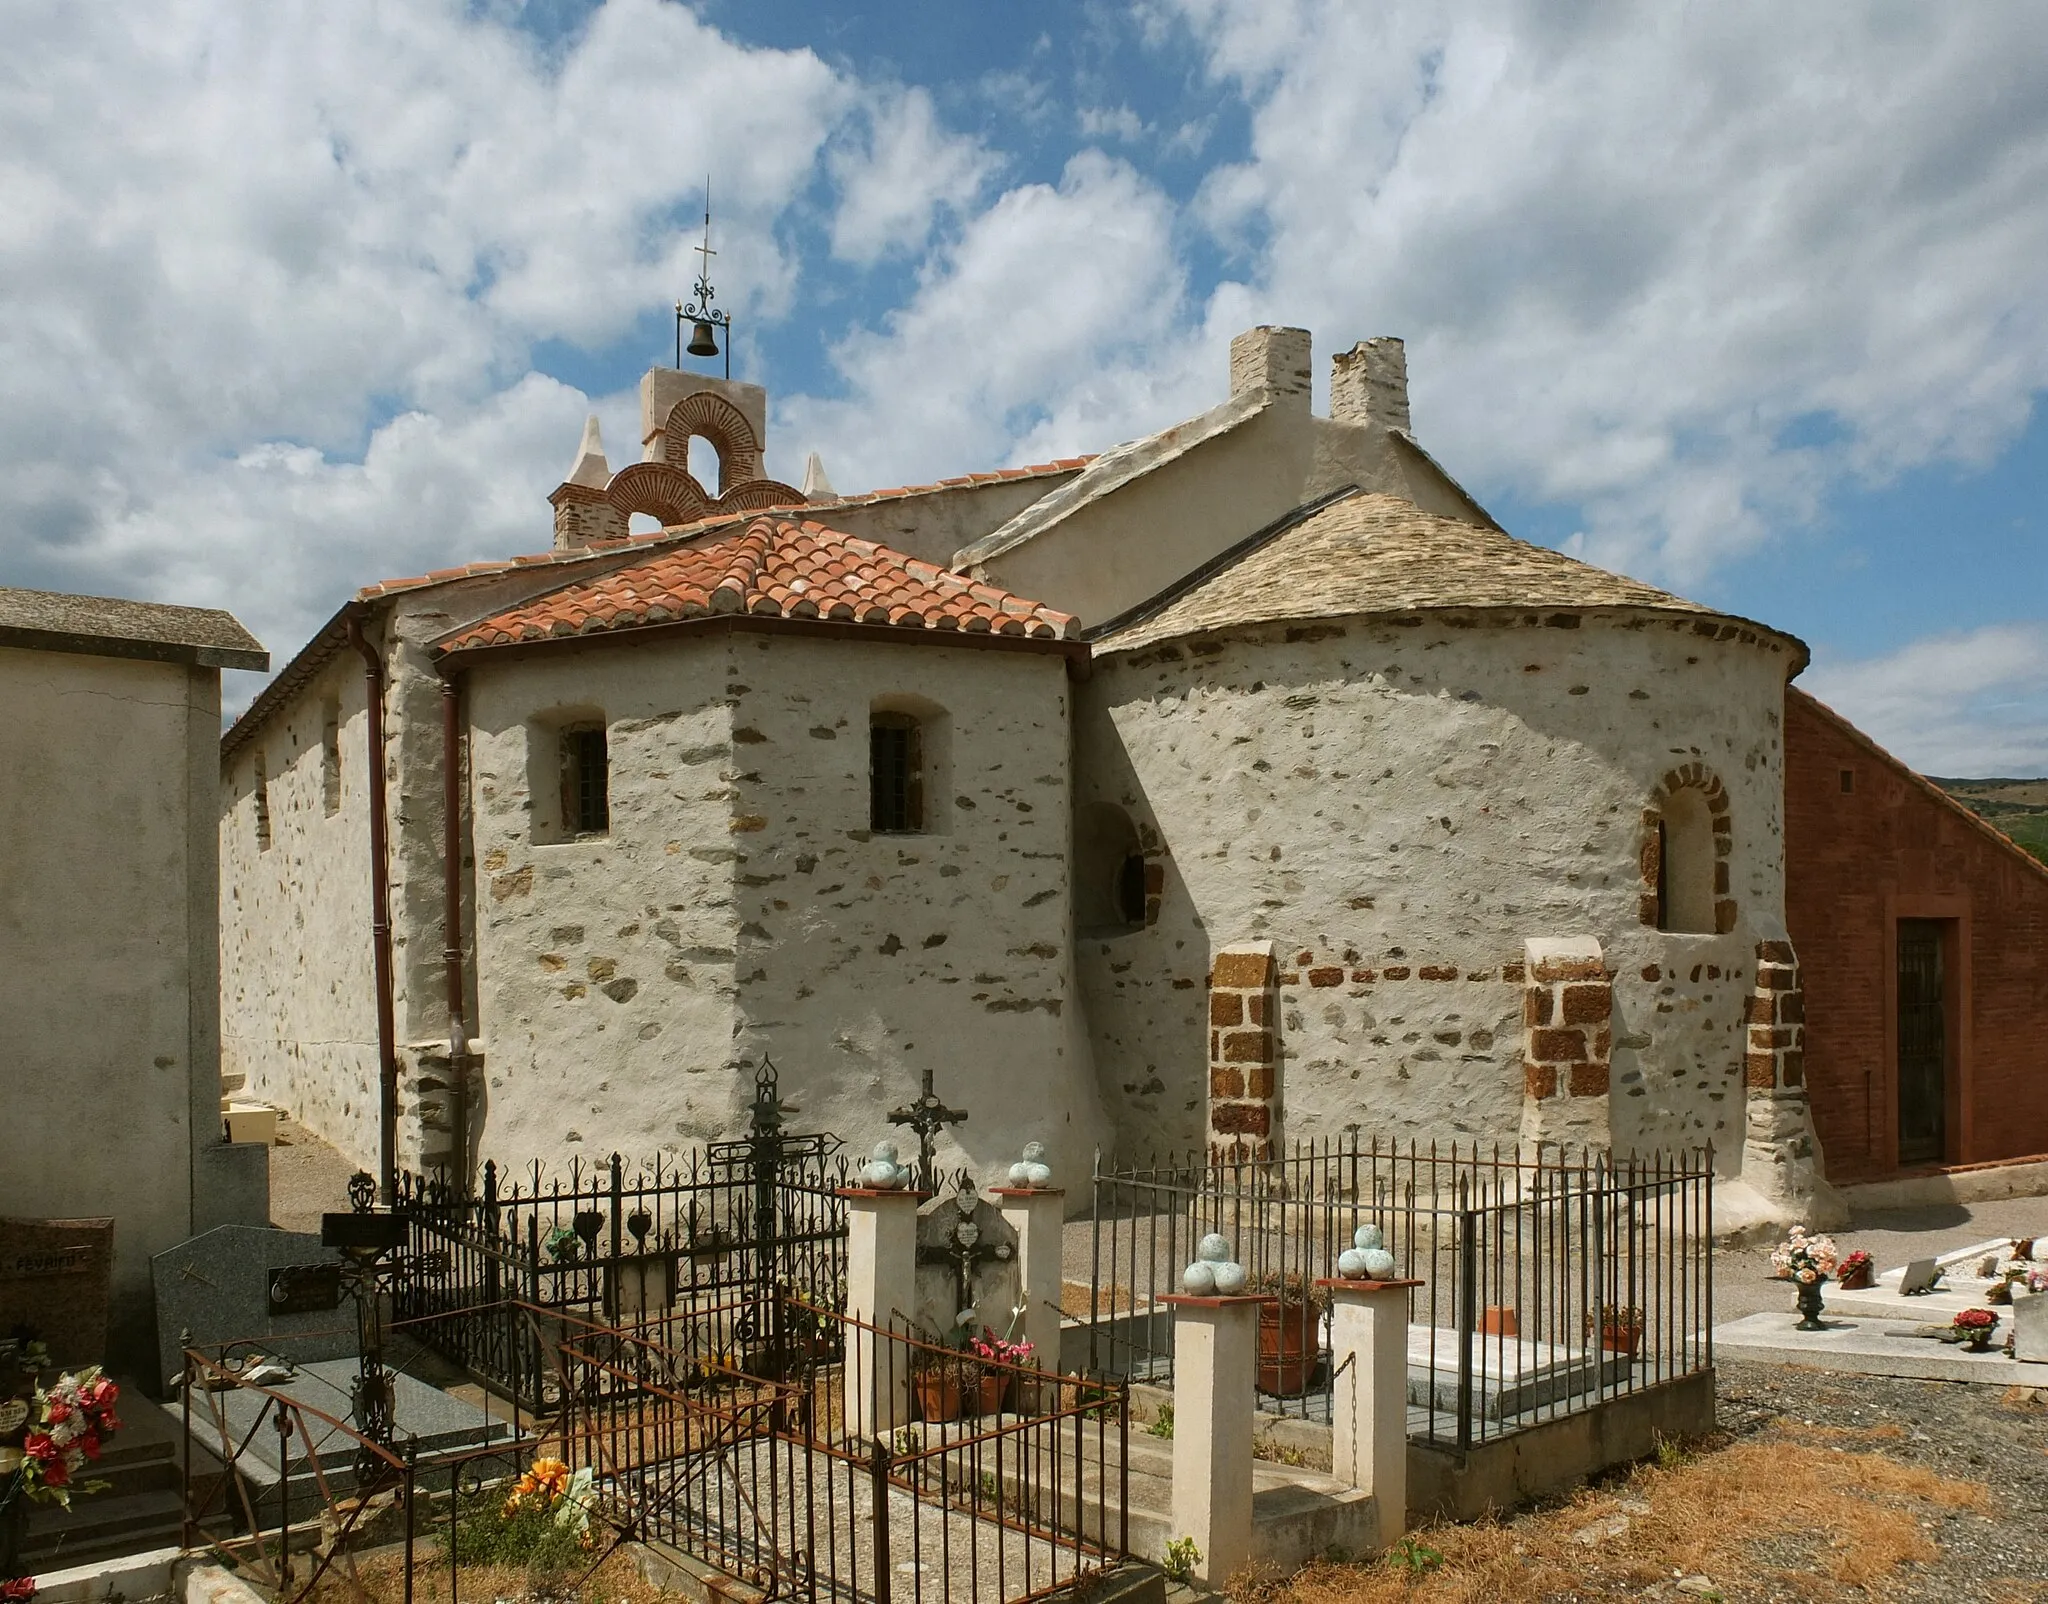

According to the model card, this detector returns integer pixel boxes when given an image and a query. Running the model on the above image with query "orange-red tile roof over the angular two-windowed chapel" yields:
[434,512,1075,653]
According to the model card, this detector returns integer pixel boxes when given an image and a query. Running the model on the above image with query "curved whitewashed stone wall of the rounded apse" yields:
[1075,615,1786,1166]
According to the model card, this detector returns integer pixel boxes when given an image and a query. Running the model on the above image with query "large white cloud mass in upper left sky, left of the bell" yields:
[0,0,966,700]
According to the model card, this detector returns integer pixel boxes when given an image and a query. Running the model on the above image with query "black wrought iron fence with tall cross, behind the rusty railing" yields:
[393,1063,850,1409]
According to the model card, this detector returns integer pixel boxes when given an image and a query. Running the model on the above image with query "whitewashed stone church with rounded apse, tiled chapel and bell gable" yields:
[221,328,1843,1211]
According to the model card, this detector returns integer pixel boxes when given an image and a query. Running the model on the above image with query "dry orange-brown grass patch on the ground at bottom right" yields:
[1233,1426,1991,1604]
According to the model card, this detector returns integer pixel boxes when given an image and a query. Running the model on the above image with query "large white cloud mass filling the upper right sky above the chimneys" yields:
[1182,0,2048,582]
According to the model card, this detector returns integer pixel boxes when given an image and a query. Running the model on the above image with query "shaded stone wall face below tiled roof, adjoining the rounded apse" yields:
[731,633,1106,1200]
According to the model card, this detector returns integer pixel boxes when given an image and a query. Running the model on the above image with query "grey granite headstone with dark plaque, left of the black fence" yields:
[150,1225,356,1383]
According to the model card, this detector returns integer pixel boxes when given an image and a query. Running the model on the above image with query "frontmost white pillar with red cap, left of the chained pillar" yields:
[1161,1295,1272,1588]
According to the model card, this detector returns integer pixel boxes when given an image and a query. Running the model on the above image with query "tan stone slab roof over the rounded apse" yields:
[1094,492,1804,662]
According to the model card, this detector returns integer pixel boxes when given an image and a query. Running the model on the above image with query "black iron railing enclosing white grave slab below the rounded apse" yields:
[1087,1137,1714,1450]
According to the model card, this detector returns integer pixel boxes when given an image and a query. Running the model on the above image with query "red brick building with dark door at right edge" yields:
[1786,686,2048,1184]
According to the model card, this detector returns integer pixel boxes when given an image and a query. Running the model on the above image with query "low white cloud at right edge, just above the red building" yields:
[1800,623,2048,778]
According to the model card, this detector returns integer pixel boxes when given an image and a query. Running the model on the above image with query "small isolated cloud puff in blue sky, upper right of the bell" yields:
[829,88,995,266]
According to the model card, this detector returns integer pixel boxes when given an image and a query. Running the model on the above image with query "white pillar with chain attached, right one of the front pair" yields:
[1317,1280,1421,1549]
